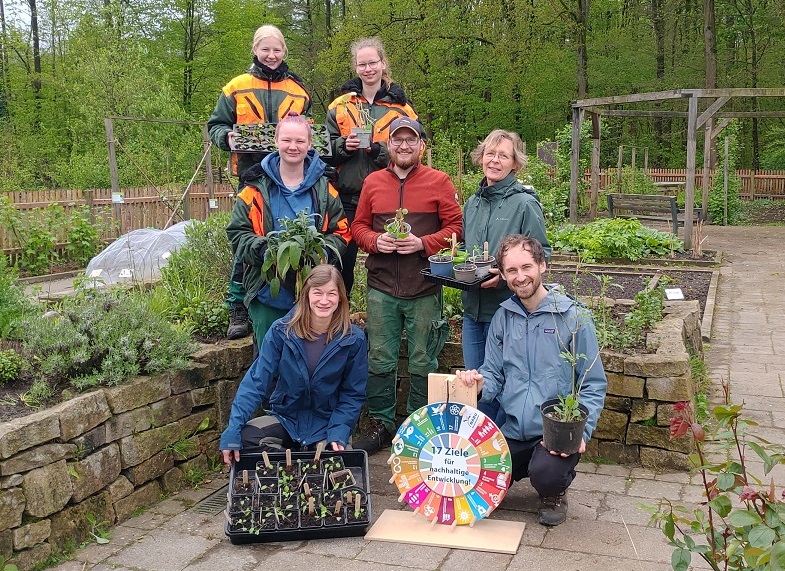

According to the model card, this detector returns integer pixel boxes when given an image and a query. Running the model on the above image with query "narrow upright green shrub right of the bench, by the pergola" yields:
[708,121,742,226]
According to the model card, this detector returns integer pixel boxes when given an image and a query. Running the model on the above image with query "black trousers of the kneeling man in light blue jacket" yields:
[507,438,581,496]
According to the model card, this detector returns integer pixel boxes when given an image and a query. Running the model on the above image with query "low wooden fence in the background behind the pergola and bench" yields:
[584,168,785,200]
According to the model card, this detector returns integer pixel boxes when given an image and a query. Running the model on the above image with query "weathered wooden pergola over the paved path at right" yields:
[570,88,785,249]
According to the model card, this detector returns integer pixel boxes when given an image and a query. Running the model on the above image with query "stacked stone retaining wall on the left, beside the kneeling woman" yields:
[0,337,253,571]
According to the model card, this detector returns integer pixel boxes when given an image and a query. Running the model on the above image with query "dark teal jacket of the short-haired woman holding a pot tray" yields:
[461,173,551,323]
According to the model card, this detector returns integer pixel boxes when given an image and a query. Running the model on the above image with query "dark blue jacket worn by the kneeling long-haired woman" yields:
[220,312,368,450]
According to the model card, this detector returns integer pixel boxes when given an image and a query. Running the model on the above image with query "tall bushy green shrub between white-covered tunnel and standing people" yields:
[152,213,233,337]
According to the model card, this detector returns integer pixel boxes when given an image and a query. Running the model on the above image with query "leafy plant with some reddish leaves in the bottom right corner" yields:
[647,383,785,571]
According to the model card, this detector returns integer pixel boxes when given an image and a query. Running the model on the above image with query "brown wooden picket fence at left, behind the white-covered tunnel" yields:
[0,183,235,257]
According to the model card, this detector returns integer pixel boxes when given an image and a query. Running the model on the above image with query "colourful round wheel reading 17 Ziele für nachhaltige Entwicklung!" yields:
[387,402,512,525]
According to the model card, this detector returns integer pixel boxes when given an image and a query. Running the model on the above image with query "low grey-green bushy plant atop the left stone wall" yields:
[15,291,193,398]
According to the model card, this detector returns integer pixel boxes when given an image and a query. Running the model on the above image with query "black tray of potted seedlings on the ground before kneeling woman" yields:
[226,448,371,544]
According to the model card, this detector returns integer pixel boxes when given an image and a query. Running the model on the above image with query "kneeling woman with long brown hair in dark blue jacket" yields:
[220,264,368,464]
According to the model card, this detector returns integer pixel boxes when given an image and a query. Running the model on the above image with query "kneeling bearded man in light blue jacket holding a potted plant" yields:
[456,234,608,526]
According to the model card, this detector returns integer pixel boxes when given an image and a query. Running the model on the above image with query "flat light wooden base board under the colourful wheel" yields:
[365,510,526,555]
